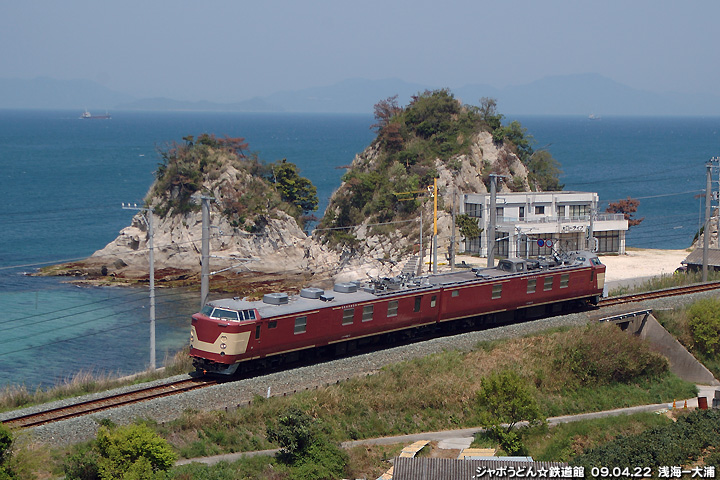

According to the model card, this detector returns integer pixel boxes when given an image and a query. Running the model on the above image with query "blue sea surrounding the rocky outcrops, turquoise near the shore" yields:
[0,110,720,389]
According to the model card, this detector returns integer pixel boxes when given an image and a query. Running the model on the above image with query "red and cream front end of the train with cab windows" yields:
[190,303,259,375]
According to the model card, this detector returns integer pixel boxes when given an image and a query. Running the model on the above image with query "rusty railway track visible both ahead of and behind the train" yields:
[3,282,720,428]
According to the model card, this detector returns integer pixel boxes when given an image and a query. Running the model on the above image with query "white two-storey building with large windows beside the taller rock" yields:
[460,192,628,257]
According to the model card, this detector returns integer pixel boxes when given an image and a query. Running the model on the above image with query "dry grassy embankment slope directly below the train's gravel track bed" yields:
[153,325,696,457]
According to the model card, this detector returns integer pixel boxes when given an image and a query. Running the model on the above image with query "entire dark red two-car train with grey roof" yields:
[190,252,605,374]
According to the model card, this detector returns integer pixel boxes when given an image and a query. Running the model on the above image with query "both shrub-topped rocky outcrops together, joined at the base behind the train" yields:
[43,90,562,292]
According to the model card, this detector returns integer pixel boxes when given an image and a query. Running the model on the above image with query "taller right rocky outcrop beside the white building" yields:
[315,90,562,280]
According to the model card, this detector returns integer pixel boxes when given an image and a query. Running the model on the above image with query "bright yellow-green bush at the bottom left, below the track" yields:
[64,422,177,480]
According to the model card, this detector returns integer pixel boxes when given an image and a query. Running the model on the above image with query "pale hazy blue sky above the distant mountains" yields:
[0,0,720,102]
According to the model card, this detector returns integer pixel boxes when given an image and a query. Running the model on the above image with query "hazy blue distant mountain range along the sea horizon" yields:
[0,74,720,116]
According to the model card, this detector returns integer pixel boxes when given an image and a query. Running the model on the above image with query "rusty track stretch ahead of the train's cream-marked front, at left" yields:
[2,379,218,428]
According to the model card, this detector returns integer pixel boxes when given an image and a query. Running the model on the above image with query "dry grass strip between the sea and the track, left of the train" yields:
[0,348,193,412]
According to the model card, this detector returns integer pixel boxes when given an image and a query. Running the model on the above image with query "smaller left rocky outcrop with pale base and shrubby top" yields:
[76,136,338,280]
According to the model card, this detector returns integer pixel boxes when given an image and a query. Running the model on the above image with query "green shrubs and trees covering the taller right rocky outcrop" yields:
[320,89,562,245]
